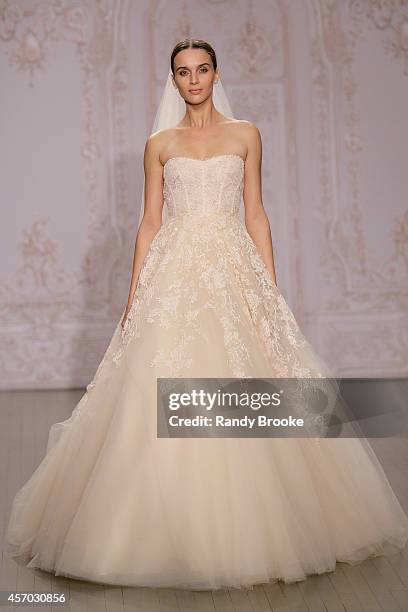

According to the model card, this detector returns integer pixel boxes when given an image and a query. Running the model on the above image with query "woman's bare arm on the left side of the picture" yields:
[122,133,163,327]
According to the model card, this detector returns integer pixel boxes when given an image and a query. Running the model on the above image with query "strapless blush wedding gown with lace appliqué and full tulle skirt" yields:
[6,154,408,589]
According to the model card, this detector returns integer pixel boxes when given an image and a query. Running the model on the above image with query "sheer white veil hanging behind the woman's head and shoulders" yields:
[137,70,234,228]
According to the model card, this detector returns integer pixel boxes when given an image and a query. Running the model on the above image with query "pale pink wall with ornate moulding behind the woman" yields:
[0,0,408,388]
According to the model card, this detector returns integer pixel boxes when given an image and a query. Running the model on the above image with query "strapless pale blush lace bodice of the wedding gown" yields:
[163,154,245,219]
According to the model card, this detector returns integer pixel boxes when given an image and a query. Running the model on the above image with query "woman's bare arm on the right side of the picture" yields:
[243,124,276,285]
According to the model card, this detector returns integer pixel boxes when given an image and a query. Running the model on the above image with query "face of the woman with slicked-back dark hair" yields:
[173,49,219,104]
